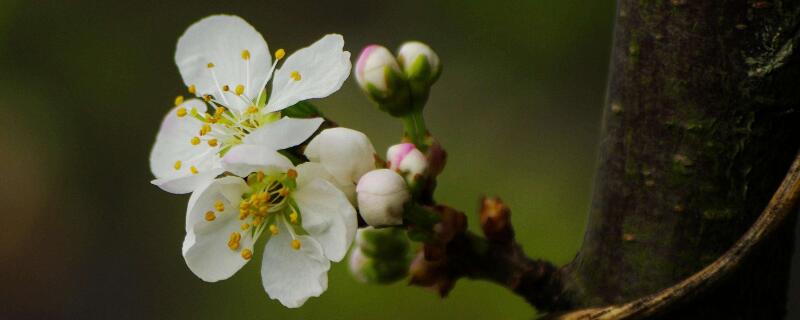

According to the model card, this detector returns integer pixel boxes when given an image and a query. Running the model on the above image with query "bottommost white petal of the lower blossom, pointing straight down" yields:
[261,223,331,308]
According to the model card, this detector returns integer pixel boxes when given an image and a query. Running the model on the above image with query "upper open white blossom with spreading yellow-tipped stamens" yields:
[150,15,350,193]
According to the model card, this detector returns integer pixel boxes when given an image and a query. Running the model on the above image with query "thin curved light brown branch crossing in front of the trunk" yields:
[550,153,800,320]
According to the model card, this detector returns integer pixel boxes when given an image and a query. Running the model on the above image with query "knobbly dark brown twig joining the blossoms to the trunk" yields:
[411,198,567,310]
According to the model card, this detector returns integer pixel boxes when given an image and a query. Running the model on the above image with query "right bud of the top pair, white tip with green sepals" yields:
[397,41,442,86]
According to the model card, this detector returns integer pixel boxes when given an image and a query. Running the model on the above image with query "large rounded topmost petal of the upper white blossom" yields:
[175,15,272,110]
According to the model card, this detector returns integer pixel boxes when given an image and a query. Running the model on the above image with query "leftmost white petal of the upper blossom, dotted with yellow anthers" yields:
[150,99,220,193]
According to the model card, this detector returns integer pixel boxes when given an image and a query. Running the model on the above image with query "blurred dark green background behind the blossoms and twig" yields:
[0,0,614,319]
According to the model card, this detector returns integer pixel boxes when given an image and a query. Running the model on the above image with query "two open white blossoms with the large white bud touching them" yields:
[150,15,375,307]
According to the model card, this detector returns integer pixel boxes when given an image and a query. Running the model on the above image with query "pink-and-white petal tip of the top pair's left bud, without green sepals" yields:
[355,44,400,92]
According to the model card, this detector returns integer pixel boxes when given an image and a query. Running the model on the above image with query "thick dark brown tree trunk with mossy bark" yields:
[564,0,800,319]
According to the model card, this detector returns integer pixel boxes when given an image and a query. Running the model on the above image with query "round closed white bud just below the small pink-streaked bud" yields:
[356,169,411,227]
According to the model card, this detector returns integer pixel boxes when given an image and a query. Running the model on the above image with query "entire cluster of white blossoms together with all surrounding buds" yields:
[150,15,444,308]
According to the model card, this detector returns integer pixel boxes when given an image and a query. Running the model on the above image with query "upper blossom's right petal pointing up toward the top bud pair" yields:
[267,34,350,112]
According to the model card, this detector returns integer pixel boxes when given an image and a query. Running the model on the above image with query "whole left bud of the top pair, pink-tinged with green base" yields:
[354,44,410,116]
